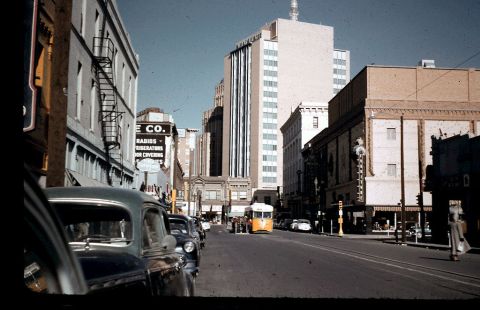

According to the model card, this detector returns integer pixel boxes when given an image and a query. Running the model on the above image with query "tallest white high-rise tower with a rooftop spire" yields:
[222,18,349,204]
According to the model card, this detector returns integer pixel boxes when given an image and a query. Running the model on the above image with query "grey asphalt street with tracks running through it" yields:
[196,225,480,300]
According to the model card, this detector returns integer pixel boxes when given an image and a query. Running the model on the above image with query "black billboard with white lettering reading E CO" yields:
[135,122,172,165]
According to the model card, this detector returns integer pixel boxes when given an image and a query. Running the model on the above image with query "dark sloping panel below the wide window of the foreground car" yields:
[75,250,145,286]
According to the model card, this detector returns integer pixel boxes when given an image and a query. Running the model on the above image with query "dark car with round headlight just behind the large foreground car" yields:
[168,214,201,277]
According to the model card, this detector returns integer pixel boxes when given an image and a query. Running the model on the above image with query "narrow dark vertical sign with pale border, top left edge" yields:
[23,0,38,132]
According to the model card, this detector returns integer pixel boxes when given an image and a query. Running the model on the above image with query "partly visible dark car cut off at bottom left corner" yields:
[20,165,88,295]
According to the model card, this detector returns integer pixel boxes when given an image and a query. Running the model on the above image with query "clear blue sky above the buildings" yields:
[117,0,480,129]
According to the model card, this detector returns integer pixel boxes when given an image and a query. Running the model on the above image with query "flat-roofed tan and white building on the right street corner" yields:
[302,66,480,232]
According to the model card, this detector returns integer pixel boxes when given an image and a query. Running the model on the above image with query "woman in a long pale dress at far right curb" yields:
[448,205,471,261]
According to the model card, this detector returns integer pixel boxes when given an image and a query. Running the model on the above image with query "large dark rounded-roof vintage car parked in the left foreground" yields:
[45,186,194,296]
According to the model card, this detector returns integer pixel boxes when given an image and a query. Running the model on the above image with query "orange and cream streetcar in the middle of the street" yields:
[245,202,273,233]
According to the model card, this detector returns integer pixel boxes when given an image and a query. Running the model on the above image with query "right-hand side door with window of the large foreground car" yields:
[142,205,189,296]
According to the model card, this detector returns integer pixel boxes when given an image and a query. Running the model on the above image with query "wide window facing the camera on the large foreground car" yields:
[53,203,133,246]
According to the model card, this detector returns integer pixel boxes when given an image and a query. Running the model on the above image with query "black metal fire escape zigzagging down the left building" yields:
[93,36,124,185]
